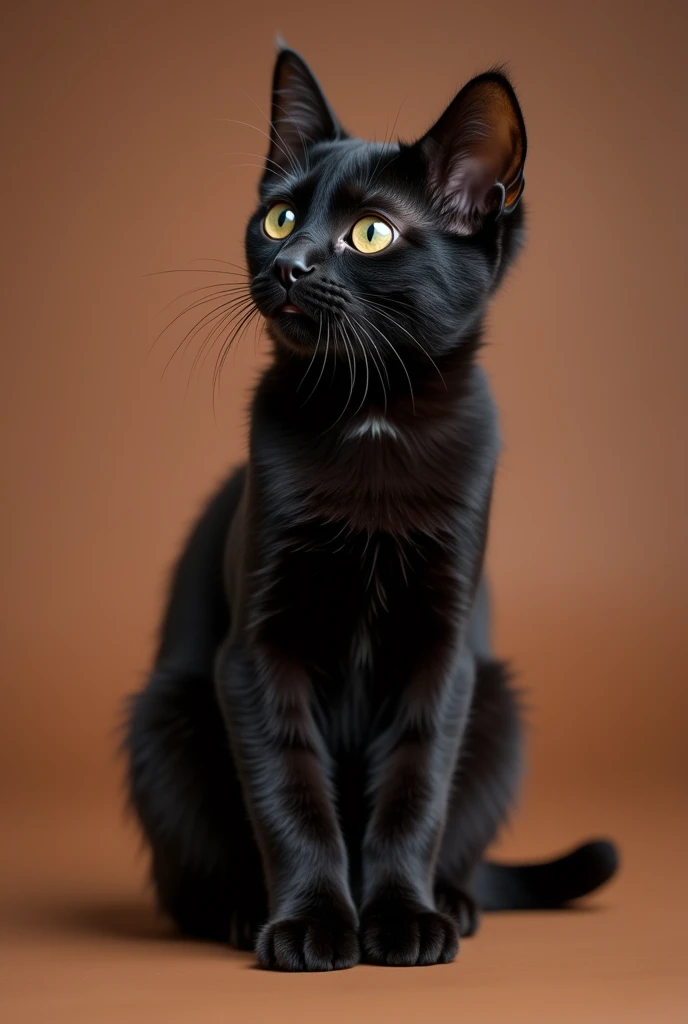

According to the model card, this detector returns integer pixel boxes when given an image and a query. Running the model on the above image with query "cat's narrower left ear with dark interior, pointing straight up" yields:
[265,47,345,177]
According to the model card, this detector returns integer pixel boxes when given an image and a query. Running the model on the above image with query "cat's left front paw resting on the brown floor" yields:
[256,913,360,971]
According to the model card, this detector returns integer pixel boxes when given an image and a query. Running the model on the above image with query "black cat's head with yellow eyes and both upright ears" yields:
[246,49,526,364]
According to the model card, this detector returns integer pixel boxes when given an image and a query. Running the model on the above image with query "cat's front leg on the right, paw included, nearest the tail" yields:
[360,654,474,967]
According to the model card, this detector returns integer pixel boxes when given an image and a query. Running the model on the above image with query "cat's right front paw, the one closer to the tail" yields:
[360,904,459,967]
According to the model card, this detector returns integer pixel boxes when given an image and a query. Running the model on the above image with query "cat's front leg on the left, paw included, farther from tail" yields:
[216,644,359,971]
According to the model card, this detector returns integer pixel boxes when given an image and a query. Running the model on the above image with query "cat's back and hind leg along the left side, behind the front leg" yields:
[125,469,267,947]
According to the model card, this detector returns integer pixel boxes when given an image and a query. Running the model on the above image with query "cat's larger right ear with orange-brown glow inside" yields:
[417,72,526,234]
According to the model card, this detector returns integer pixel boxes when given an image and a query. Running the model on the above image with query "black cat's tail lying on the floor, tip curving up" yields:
[473,840,618,910]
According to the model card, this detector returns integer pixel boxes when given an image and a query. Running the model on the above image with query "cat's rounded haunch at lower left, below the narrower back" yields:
[127,671,267,949]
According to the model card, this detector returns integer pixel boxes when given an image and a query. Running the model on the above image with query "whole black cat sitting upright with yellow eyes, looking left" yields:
[127,49,616,971]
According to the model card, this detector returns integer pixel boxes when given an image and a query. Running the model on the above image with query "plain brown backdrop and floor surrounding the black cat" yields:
[0,0,688,1022]
